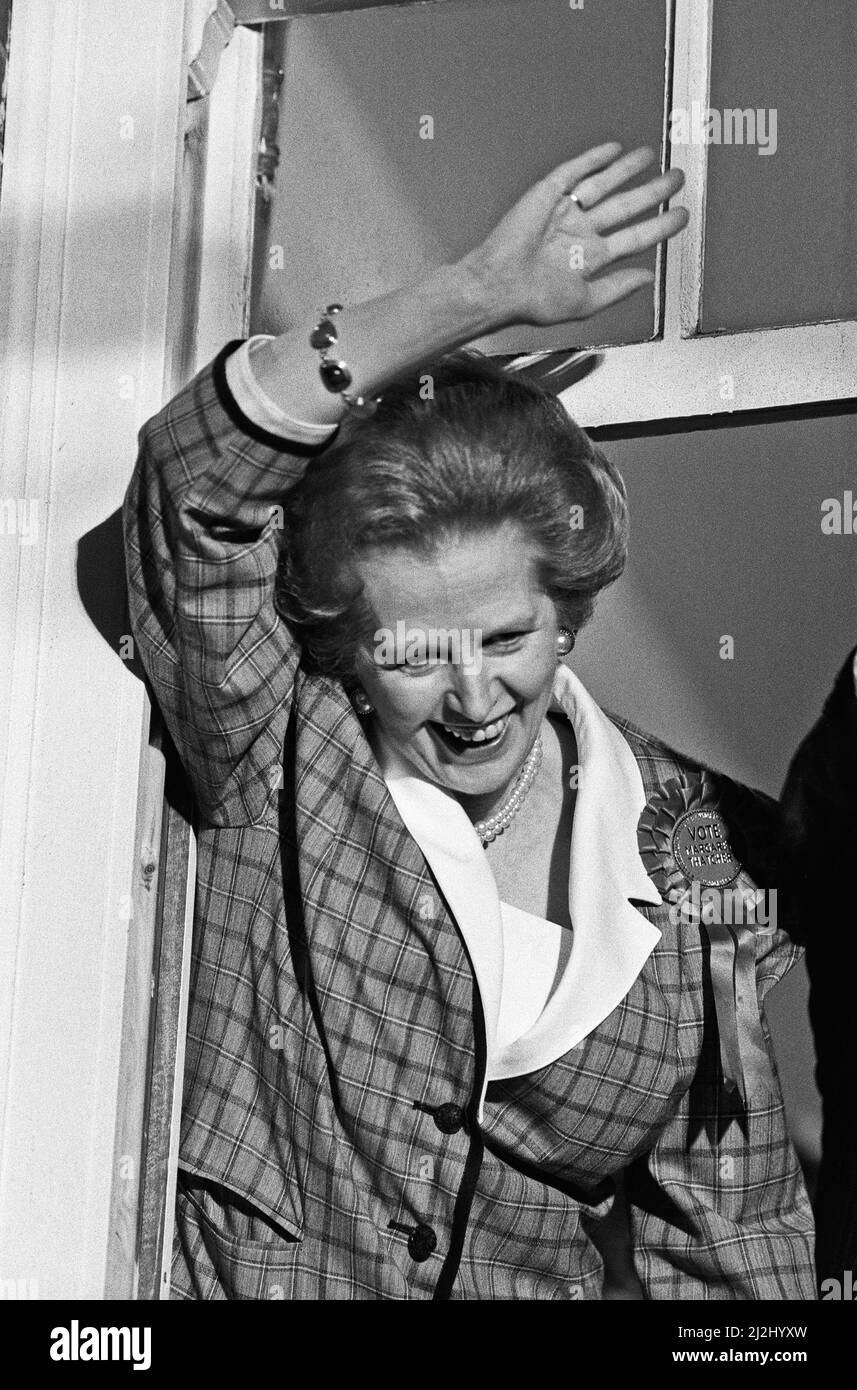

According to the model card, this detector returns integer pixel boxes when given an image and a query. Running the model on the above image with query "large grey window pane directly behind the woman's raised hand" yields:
[247,0,665,352]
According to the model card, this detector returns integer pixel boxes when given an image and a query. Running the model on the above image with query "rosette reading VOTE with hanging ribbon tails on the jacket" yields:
[638,770,772,1105]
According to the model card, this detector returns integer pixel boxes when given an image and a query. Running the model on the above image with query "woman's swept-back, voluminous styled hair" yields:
[275,350,628,684]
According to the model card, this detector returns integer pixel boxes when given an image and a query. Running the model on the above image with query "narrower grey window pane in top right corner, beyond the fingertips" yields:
[701,0,857,332]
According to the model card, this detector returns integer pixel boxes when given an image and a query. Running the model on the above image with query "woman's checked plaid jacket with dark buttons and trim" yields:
[125,343,815,1300]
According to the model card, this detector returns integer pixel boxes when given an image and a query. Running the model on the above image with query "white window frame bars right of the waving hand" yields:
[232,0,857,428]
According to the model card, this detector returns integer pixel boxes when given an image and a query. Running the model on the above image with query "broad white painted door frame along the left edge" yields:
[0,0,260,1298]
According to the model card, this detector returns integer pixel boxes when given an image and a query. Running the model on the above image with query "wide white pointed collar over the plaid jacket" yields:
[376,666,661,1119]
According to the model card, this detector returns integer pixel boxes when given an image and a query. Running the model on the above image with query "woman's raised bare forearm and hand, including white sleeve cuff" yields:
[253,142,688,424]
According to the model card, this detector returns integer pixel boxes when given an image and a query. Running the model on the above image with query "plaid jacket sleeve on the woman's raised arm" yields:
[124,343,331,826]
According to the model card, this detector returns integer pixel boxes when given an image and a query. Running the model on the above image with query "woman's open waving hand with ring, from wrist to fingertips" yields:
[460,142,688,324]
